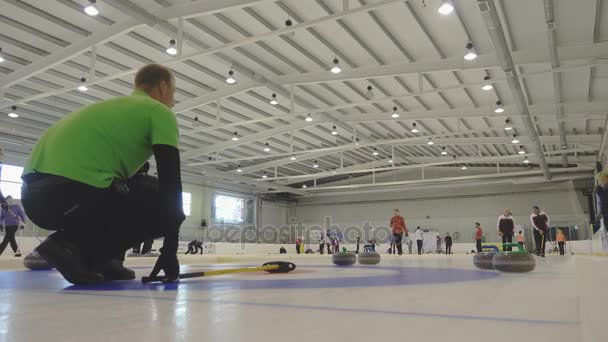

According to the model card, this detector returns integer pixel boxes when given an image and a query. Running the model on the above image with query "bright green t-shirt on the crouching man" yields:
[24,90,179,188]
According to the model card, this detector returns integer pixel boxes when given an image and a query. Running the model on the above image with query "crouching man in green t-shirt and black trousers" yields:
[22,64,185,285]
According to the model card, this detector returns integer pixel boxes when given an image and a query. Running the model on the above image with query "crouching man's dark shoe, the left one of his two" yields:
[36,233,104,285]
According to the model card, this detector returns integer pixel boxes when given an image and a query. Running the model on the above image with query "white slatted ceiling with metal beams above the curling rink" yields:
[0,0,608,194]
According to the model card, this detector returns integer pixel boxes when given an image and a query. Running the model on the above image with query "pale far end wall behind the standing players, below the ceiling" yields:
[293,182,588,242]
